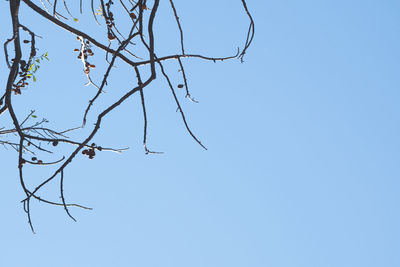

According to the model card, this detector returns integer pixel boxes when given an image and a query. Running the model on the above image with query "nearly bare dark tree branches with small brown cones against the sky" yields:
[0,0,254,231]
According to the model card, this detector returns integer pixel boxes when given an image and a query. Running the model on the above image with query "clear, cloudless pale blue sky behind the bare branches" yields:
[0,0,400,267]
